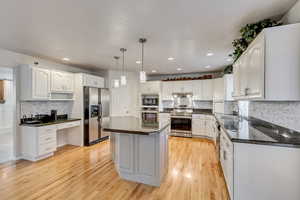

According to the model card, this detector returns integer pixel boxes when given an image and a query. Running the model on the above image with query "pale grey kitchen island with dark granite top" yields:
[103,117,170,186]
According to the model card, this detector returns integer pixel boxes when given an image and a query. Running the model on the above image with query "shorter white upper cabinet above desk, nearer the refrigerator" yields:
[51,71,74,93]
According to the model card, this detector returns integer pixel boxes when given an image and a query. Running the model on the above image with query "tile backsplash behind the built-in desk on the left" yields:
[20,101,73,117]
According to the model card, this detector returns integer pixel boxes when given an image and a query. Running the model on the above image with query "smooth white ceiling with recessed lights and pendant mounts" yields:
[0,0,296,73]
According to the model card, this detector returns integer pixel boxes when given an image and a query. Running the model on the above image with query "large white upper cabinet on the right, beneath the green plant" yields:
[233,24,300,101]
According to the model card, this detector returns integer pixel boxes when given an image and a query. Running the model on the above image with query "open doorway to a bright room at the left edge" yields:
[0,67,16,163]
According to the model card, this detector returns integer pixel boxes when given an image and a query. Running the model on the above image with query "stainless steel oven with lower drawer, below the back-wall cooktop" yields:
[171,115,192,137]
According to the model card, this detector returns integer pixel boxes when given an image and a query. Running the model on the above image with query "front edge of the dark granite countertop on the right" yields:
[214,115,300,148]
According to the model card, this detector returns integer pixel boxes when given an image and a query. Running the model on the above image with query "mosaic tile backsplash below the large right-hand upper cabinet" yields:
[248,101,300,132]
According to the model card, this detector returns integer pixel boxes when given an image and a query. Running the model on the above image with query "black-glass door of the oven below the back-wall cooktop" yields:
[171,117,192,134]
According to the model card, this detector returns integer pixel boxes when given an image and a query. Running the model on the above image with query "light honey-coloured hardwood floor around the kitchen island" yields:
[0,137,228,200]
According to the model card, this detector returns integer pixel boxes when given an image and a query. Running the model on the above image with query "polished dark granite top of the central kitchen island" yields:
[103,117,170,135]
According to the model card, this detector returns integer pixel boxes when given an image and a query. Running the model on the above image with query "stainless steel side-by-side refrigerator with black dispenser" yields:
[83,87,110,146]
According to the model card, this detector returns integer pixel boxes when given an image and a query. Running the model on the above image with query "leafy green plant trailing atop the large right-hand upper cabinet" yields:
[229,19,281,61]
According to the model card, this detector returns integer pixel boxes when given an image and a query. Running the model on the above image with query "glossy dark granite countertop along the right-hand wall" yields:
[215,114,300,148]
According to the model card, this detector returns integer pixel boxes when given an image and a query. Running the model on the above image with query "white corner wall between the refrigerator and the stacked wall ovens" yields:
[107,70,139,117]
